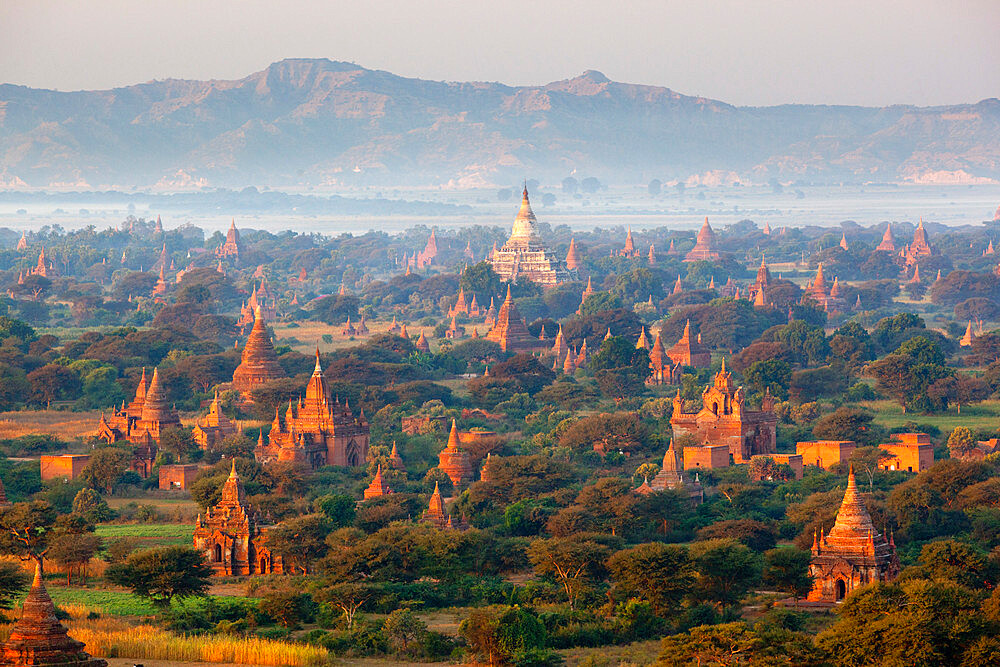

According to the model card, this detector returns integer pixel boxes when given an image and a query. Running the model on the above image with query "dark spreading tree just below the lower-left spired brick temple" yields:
[104,546,212,610]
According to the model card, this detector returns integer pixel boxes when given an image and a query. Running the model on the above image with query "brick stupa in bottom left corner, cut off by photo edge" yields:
[0,558,108,667]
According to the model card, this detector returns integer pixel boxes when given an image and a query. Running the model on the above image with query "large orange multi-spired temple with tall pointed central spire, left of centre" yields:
[254,350,369,468]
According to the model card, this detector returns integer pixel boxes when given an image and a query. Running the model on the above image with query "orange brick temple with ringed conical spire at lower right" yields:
[807,466,899,603]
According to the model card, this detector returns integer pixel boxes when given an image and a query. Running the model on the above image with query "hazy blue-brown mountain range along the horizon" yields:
[0,60,1000,189]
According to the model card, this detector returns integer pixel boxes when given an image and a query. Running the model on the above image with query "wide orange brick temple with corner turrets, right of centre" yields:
[670,359,778,463]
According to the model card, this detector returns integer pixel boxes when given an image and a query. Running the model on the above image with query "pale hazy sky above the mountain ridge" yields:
[0,0,1000,106]
